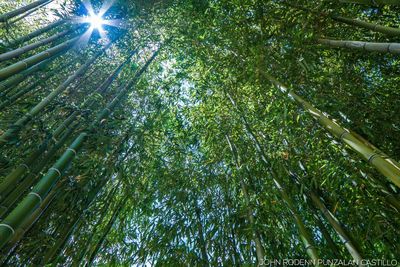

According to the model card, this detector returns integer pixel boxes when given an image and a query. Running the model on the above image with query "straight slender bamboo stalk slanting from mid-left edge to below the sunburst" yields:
[0,43,112,148]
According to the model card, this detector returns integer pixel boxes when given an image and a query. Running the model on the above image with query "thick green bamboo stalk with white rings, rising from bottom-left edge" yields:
[0,49,160,248]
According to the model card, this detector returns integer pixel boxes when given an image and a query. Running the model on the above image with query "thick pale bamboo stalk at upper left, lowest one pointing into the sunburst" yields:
[0,37,79,81]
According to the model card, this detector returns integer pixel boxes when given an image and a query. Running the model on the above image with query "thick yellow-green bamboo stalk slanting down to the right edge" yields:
[264,73,400,187]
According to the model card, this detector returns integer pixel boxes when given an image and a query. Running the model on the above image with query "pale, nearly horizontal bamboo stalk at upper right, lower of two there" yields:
[317,39,400,54]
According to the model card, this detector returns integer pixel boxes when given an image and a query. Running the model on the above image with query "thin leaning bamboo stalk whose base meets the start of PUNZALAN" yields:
[225,92,319,262]
